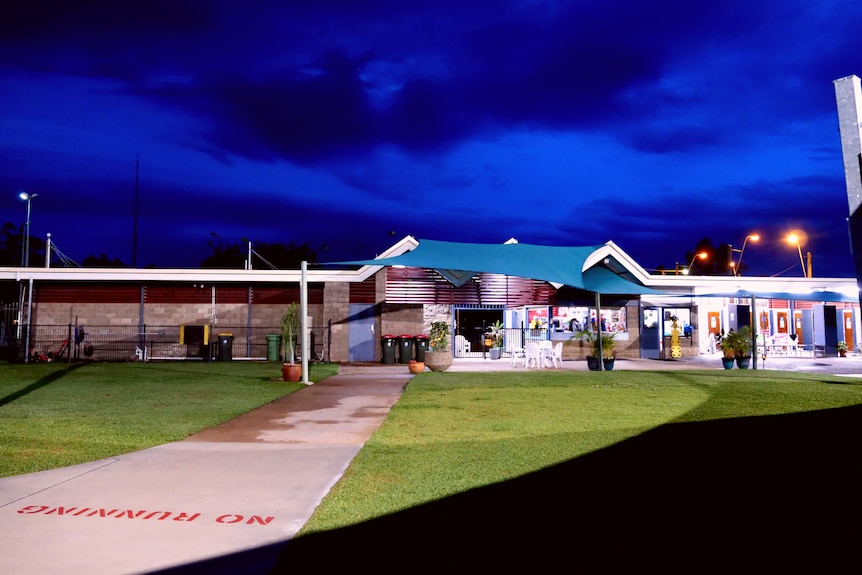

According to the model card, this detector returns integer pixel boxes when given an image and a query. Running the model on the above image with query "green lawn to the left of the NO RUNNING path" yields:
[0,362,337,477]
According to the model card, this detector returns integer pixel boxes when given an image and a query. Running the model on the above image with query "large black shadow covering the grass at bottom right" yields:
[272,406,862,574]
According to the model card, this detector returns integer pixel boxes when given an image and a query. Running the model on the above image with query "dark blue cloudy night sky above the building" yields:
[0,0,862,277]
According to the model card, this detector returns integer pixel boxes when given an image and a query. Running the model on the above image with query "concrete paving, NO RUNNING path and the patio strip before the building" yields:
[0,356,862,575]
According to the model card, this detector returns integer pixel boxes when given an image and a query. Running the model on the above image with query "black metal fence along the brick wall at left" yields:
[18,324,330,363]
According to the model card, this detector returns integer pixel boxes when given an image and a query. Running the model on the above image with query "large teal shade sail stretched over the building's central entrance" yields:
[336,240,662,294]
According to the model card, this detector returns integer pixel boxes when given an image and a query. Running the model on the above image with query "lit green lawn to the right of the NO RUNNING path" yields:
[302,370,862,535]
